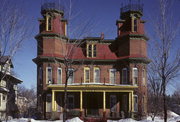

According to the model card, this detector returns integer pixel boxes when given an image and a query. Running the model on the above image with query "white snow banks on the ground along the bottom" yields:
[3,112,180,122]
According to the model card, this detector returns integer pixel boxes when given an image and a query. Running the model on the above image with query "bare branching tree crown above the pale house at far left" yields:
[0,0,31,79]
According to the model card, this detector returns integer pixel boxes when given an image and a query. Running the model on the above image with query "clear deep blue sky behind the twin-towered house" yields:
[13,0,180,93]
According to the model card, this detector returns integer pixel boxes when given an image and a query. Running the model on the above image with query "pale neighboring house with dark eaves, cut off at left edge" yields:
[0,56,22,120]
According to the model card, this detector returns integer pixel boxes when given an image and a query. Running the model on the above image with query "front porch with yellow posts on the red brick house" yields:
[47,86,137,118]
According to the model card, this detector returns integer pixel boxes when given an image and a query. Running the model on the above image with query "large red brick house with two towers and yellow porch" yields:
[33,3,150,119]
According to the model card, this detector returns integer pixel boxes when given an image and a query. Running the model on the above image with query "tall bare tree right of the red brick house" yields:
[149,0,180,122]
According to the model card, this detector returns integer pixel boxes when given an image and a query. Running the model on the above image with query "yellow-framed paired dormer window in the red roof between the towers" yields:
[87,44,97,57]
